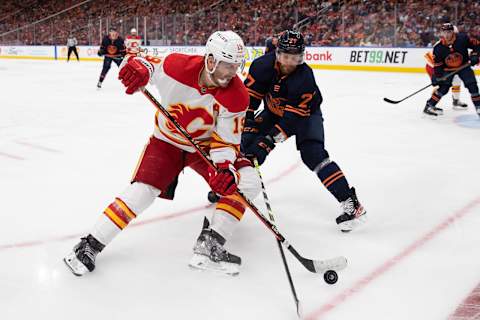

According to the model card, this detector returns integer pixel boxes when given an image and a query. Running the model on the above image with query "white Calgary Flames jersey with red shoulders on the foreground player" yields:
[143,53,249,163]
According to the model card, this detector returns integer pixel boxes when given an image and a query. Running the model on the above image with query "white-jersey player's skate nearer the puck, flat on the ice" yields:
[189,219,242,276]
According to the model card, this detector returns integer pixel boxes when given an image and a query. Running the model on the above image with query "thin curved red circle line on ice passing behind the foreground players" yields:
[0,162,300,251]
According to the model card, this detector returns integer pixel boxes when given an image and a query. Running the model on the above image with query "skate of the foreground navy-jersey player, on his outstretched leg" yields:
[336,188,367,232]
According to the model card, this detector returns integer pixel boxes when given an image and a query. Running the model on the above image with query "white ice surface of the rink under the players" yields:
[0,60,480,320]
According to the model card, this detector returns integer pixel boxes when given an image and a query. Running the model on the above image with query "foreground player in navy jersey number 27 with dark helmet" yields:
[241,30,366,232]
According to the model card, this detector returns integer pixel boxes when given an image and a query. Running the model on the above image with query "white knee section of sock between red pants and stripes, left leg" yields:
[119,182,160,216]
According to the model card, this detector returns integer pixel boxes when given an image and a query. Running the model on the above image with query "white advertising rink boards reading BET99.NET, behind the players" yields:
[0,46,480,74]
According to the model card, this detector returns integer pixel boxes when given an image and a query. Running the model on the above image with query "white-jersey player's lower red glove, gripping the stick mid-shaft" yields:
[208,161,238,196]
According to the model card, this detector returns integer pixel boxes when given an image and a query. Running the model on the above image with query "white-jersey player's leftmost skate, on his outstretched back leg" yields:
[63,234,105,276]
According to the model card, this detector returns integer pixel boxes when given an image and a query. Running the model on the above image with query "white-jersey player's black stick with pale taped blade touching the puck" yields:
[142,88,347,278]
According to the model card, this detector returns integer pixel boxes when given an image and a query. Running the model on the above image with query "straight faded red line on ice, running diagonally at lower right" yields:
[306,197,480,320]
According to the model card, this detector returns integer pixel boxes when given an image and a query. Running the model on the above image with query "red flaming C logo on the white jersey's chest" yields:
[166,103,215,138]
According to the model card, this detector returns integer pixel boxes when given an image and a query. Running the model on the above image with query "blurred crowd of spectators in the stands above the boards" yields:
[0,0,480,47]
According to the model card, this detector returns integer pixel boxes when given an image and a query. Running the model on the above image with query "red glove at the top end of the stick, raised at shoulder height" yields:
[118,57,153,94]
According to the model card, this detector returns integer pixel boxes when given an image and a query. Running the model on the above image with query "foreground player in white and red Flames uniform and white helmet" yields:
[64,31,260,276]
